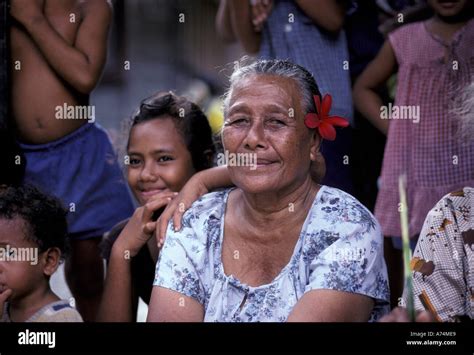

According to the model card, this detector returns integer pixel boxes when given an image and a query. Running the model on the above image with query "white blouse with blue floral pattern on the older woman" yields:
[154,186,389,322]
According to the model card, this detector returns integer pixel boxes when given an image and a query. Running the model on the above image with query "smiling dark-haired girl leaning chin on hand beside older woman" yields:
[98,92,214,322]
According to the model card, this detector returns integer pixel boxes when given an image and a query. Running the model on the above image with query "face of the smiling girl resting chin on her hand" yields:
[127,117,195,205]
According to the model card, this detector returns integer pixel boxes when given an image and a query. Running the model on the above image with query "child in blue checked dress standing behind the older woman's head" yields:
[216,0,353,193]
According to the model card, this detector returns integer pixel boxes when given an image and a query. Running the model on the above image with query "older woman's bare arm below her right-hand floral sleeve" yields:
[288,290,374,322]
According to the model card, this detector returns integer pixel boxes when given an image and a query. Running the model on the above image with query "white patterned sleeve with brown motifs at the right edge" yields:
[403,197,470,321]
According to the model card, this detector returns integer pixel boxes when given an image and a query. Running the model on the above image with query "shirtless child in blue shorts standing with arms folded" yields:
[10,0,133,321]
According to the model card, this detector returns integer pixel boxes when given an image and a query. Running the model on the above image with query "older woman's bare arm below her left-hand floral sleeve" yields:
[147,286,204,322]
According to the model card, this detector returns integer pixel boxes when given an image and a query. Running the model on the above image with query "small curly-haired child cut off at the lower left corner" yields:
[0,185,82,322]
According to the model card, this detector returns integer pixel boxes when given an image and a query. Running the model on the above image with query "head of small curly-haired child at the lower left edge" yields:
[0,185,67,302]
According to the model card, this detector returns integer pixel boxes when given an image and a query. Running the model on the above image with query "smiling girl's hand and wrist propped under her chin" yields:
[113,190,177,257]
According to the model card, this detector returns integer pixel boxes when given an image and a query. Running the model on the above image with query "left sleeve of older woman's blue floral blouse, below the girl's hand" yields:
[153,216,205,304]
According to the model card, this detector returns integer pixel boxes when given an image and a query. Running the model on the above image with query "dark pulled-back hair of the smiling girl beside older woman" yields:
[127,92,215,171]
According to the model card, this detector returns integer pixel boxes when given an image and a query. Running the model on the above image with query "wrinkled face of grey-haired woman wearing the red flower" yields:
[222,75,319,193]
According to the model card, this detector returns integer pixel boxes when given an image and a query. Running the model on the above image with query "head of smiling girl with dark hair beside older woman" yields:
[127,92,214,205]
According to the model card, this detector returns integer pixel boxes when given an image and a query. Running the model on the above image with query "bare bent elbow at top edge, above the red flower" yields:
[295,0,347,33]
